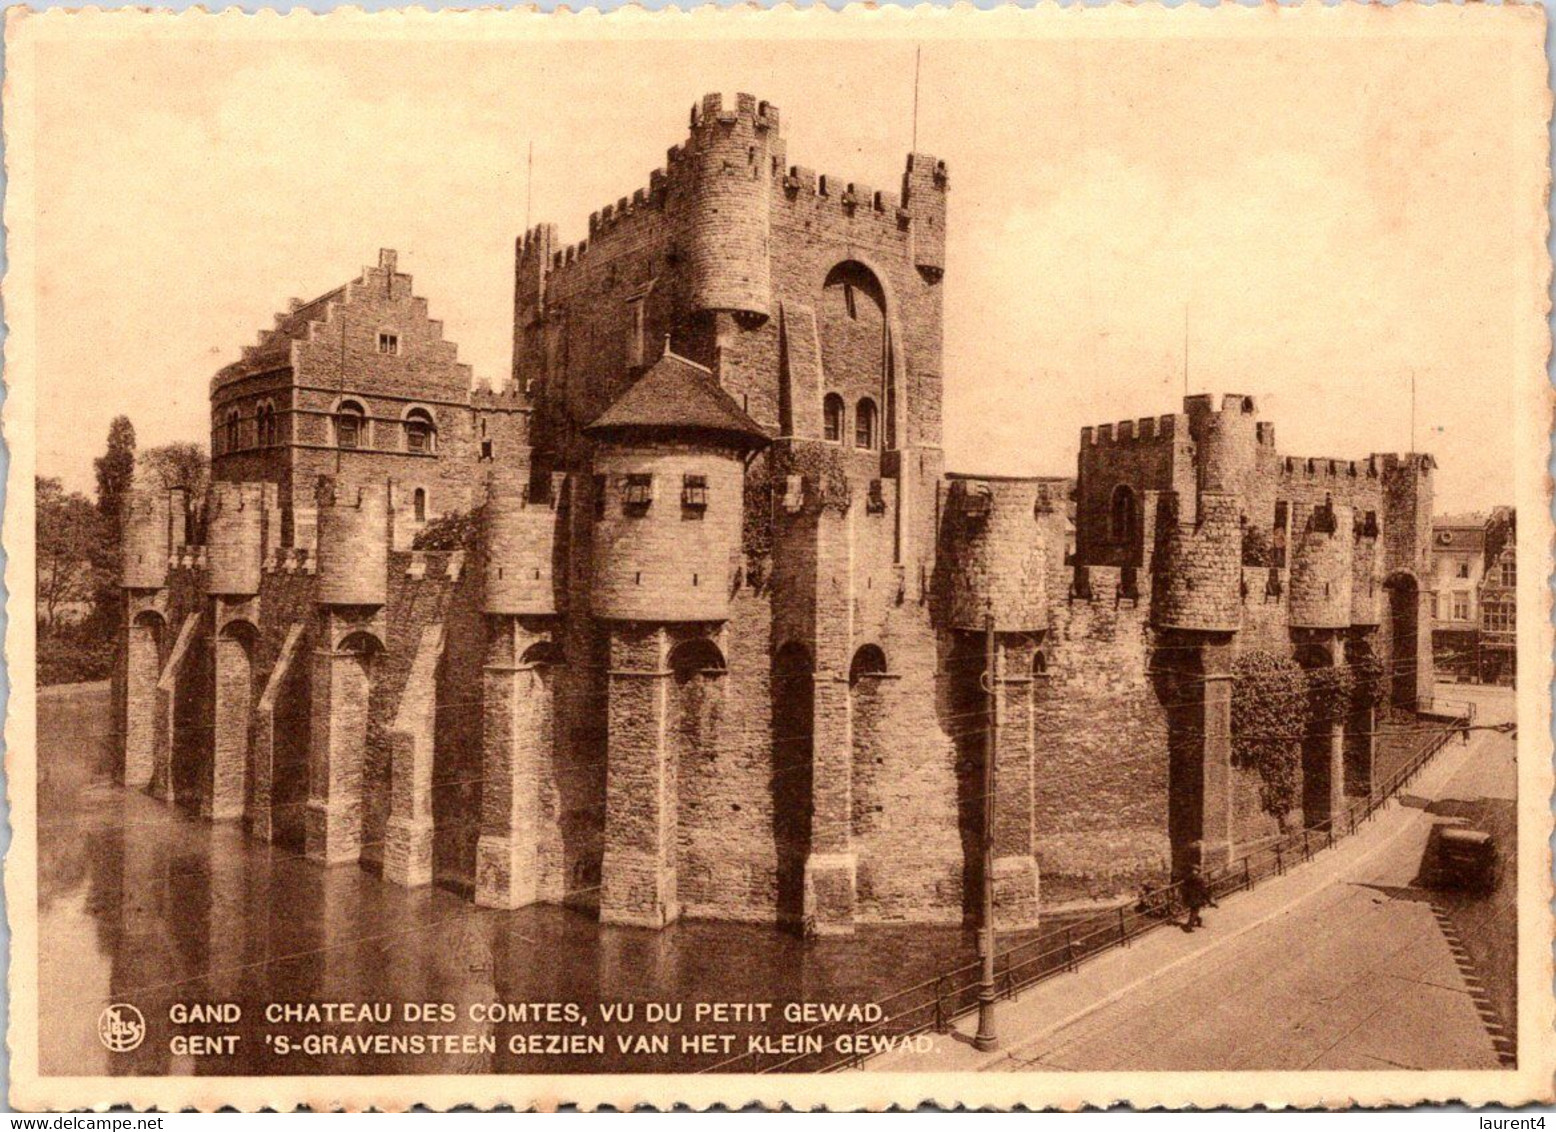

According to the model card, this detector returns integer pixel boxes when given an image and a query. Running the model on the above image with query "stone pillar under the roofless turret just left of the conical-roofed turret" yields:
[476,616,552,908]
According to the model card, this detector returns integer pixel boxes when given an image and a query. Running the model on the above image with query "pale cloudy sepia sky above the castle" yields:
[24,12,1544,512]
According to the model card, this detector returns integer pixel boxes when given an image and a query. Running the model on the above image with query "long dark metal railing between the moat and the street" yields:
[702,700,1475,1073]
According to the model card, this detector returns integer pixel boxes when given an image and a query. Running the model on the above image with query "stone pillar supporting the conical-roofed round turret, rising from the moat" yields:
[599,622,680,928]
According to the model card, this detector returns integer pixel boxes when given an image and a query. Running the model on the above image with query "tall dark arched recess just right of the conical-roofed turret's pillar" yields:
[770,642,815,927]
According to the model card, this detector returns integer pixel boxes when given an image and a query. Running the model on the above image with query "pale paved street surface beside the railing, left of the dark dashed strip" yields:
[865,712,1505,1071]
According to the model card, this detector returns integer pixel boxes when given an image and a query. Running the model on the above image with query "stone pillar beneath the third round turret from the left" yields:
[305,614,372,865]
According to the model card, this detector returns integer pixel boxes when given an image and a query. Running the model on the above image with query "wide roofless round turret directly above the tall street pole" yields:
[948,479,1064,633]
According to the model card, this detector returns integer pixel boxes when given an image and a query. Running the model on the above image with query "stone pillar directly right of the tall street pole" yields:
[994,634,1039,930]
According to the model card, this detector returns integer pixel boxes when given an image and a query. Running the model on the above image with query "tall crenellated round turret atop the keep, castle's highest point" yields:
[685,95,778,317]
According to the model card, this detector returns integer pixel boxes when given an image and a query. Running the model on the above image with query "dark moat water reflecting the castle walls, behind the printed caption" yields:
[37,686,1076,1076]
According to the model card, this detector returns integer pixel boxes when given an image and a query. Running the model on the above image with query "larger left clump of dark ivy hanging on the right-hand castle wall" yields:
[1232,650,1309,819]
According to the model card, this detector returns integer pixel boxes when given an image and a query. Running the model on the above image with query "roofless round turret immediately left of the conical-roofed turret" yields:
[484,476,557,616]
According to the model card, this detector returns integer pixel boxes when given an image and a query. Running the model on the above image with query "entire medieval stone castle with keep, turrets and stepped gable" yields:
[115,95,1433,935]
